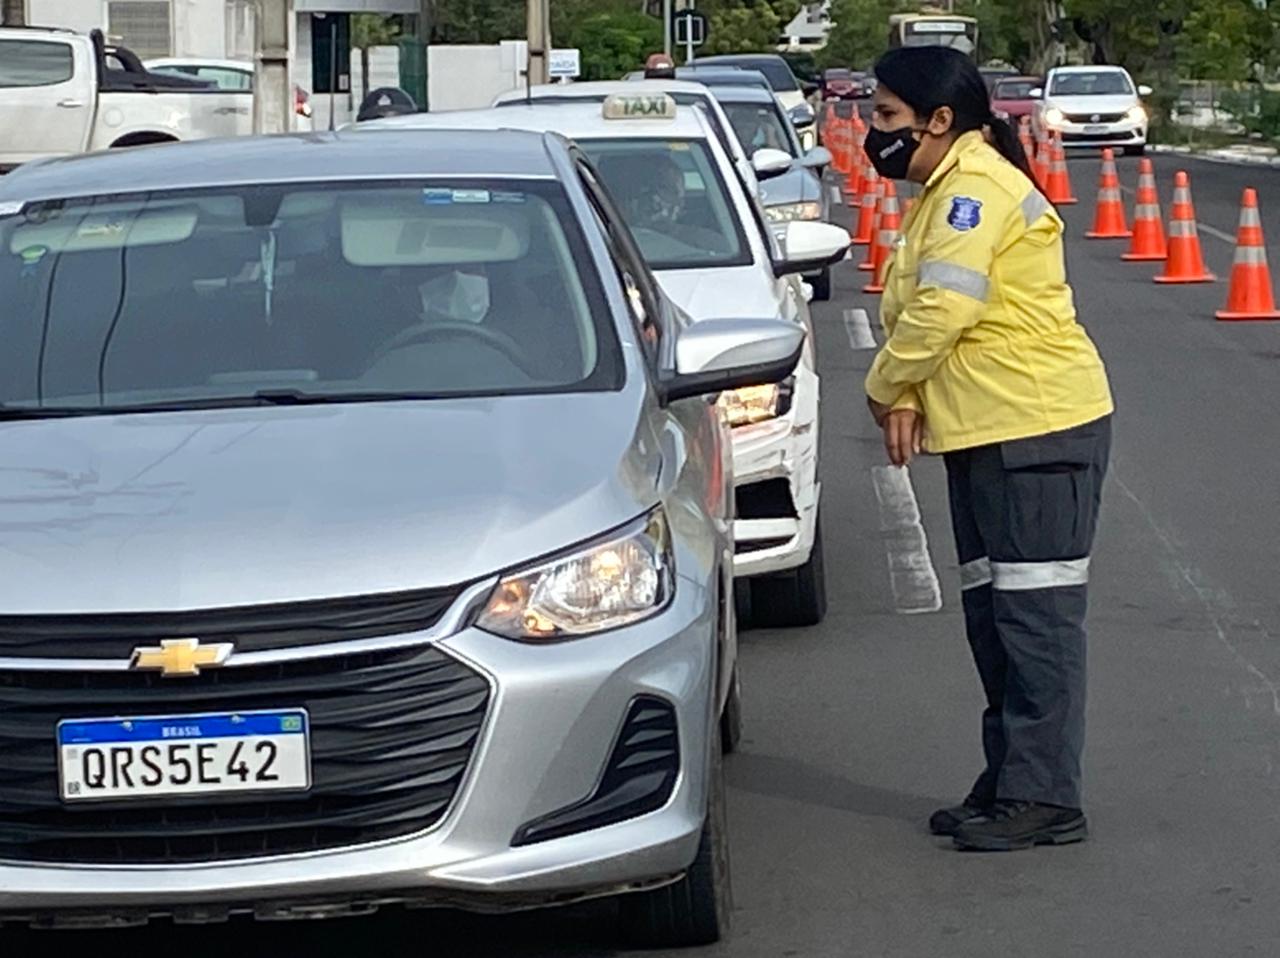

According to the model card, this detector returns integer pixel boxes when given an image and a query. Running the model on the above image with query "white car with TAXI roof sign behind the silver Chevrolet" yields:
[361,93,849,625]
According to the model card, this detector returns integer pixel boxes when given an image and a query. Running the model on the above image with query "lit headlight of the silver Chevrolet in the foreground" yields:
[476,508,675,642]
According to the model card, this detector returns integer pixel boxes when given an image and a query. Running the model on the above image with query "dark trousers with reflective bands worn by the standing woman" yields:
[946,416,1111,808]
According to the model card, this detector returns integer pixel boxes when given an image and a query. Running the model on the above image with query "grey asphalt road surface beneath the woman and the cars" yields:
[4,158,1280,958]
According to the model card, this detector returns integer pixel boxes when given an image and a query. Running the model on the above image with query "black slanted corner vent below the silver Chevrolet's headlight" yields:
[511,695,680,847]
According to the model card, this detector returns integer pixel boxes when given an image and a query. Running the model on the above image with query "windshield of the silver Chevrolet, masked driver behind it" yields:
[0,181,620,416]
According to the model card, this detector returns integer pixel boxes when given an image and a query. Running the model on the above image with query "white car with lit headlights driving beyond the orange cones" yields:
[1032,67,1151,156]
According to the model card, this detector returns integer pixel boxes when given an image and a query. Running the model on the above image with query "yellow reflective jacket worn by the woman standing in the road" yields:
[867,132,1114,452]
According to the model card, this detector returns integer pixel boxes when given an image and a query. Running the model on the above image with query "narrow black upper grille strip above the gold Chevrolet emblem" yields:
[0,587,462,658]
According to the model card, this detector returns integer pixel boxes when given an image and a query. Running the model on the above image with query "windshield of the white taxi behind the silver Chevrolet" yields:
[579,140,751,270]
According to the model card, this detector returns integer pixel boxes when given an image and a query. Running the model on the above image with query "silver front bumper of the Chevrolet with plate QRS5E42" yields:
[0,578,718,926]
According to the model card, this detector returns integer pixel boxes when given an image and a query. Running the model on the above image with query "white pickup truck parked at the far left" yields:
[0,27,252,170]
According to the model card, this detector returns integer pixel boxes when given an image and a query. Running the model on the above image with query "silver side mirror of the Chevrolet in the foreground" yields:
[663,319,805,401]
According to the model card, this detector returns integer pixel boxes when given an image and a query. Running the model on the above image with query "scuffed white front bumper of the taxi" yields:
[733,364,820,578]
